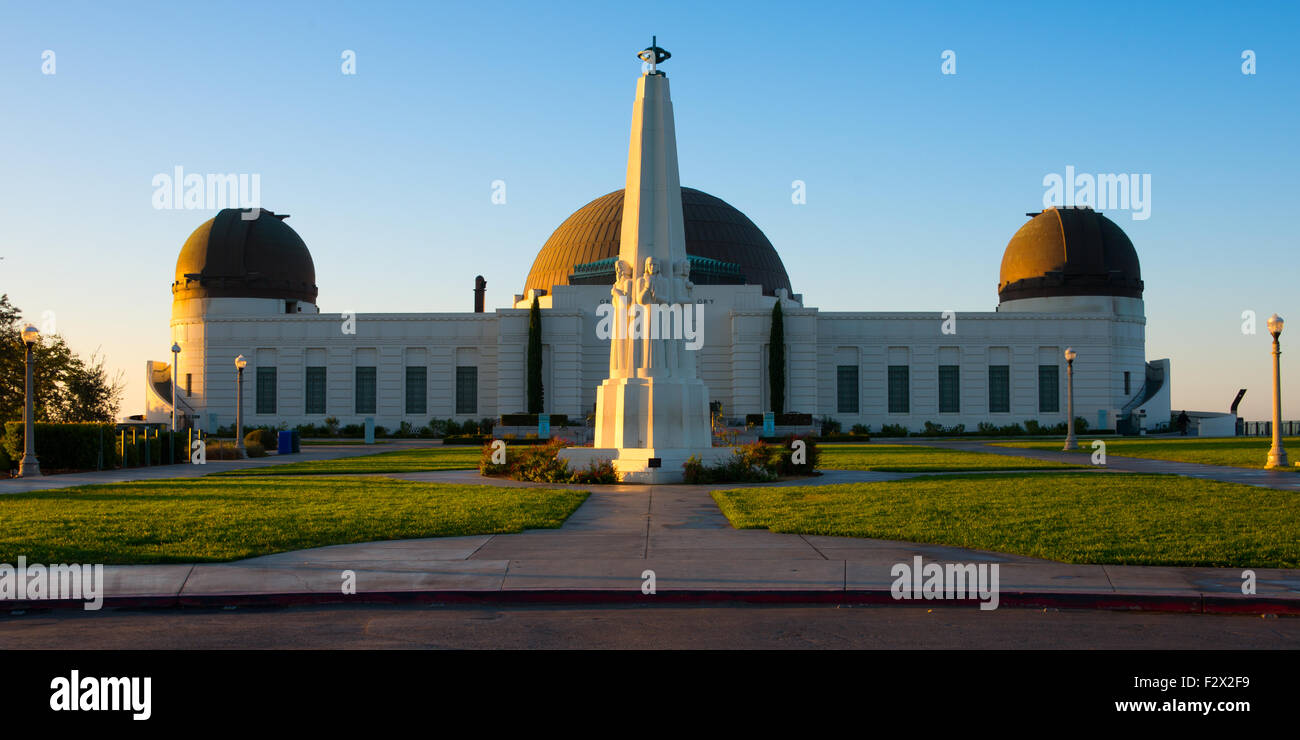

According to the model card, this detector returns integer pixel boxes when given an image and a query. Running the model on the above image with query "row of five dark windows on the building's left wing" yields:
[256,365,478,416]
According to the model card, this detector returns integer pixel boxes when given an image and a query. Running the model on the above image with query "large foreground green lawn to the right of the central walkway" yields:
[712,472,1300,568]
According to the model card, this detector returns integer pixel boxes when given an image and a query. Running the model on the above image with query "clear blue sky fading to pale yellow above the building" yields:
[0,1,1300,419]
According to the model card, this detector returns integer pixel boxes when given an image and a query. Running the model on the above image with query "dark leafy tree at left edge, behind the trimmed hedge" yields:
[0,294,126,421]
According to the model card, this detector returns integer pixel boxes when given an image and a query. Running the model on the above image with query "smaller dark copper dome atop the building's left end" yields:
[172,208,316,303]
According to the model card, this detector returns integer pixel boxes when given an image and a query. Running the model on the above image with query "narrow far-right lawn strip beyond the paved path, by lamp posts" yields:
[995,434,1300,468]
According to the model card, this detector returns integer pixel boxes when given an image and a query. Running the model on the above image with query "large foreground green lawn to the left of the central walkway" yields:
[0,477,588,563]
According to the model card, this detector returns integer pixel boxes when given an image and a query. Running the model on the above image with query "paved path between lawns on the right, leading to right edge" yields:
[897,438,1300,490]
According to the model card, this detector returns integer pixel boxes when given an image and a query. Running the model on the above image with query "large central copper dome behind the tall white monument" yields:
[524,187,793,295]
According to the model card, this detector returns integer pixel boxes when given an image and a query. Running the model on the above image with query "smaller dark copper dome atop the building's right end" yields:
[997,207,1143,302]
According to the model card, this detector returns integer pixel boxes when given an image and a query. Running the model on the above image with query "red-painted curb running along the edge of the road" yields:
[0,589,1300,616]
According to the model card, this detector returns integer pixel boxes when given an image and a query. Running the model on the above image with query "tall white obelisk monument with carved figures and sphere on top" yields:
[560,42,732,482]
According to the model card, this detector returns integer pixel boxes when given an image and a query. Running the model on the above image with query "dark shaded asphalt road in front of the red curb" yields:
[0,605,1300,650]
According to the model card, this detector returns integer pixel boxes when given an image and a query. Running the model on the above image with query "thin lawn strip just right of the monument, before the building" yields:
[818,445,1086,473]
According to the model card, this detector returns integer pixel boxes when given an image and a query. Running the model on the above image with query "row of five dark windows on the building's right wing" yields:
[835,365,1060,414]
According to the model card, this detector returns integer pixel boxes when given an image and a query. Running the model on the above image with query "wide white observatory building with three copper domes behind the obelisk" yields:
[146,73,1170,433]
